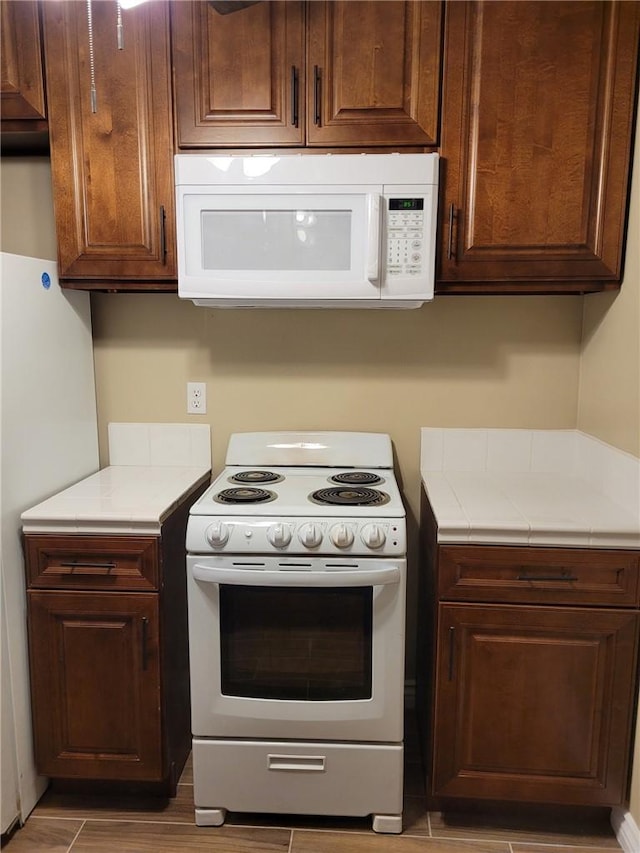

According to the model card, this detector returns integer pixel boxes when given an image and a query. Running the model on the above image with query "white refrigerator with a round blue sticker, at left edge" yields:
[0,252,98,832]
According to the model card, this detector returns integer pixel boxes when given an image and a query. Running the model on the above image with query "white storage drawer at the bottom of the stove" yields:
[193,738,403,816]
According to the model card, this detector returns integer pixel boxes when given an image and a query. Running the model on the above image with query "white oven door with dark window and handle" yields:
[187,556,406,742]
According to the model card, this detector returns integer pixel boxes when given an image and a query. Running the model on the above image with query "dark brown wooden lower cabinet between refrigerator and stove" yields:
[24,477,208,794]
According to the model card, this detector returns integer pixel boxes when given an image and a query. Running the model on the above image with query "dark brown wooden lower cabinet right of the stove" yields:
[417,493,640,810]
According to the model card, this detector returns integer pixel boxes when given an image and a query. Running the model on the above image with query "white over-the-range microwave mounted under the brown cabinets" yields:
[175,152,438,308]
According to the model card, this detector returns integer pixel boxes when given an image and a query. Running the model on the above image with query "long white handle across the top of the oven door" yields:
[193,563,400,587]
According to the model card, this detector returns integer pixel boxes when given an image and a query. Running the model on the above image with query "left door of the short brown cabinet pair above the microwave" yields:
[171,0,305,148]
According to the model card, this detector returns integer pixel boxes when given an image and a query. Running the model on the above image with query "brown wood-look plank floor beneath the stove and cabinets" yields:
[2,721,620,853]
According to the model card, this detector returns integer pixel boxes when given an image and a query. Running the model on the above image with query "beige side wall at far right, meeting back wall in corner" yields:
[577,122,640,827]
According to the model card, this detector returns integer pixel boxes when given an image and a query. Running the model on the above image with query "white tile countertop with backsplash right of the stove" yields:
[421,428,640,548]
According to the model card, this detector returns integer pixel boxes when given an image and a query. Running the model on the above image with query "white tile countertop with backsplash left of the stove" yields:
[21,423,211,536]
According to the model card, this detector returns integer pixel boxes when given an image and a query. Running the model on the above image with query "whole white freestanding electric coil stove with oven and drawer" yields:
[187,432,406,832]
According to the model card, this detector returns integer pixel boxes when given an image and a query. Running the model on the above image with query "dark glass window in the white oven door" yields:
[220,585,373,702]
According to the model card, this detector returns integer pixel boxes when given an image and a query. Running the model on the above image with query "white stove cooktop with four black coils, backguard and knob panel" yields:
[187,432,406,557]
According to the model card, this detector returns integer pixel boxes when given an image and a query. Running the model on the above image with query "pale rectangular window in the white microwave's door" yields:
[201,209,352,271]
